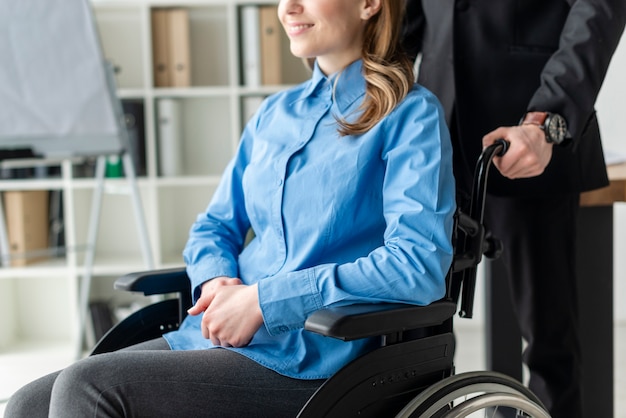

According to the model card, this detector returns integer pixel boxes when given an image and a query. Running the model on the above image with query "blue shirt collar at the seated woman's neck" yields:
[303,60,366,113]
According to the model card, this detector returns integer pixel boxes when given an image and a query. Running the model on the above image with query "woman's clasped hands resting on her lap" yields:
[187,277,263,347]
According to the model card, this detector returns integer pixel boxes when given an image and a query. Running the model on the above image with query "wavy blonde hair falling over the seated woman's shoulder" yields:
[338,0,415,136]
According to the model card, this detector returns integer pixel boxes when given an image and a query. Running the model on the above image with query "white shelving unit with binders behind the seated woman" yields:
[0,0,309,353]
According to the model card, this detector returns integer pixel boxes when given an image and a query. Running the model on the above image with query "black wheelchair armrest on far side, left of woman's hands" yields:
[114,267,191,296]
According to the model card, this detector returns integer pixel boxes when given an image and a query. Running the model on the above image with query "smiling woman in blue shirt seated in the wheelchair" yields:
[6,0,455,418]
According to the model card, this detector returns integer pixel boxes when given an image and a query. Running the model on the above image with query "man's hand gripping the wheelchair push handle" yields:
[483,124,554,179]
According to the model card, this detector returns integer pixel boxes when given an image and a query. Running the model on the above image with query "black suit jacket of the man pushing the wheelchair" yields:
[403,0,626,196]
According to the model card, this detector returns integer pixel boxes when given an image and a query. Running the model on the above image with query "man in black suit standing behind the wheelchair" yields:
[404,0,626,418]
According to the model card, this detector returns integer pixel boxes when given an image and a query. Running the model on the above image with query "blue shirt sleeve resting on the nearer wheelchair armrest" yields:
[259,94,456,335]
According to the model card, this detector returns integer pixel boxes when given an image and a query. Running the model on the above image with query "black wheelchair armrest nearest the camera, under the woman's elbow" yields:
[304,300,456,341]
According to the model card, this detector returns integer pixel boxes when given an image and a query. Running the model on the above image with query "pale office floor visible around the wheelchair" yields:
[0,323,626,418]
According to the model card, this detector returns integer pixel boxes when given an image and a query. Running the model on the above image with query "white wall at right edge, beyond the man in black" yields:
[596,36,626,321]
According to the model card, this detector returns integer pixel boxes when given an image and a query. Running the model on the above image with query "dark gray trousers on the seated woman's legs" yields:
[5,338,324,418]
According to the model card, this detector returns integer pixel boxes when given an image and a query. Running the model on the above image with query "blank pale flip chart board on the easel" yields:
[0,0,128,158]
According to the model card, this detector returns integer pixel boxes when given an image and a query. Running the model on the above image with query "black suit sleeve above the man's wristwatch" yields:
[528,0,626,140]
